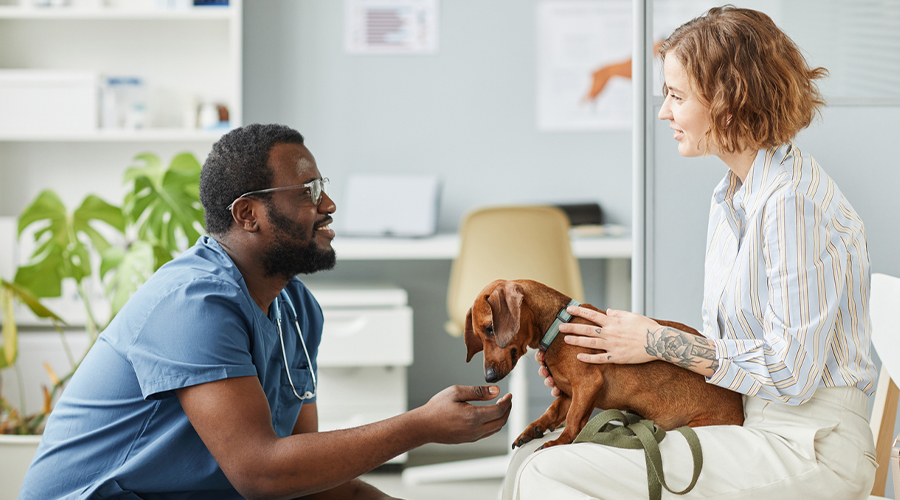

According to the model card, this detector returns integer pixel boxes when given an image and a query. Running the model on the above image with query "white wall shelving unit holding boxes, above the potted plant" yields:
[0,0,243,216]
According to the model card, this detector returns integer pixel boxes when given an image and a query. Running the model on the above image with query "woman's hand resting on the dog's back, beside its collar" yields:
[559,306,661,364]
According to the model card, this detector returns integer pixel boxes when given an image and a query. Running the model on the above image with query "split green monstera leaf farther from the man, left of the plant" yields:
[14,191,125,297]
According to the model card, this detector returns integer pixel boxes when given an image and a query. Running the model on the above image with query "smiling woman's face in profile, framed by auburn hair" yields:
[659,55,715,157]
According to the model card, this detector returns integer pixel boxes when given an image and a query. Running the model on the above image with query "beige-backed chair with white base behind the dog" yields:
[402,206,584,484]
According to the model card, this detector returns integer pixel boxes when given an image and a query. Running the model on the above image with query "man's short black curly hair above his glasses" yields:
[200,123,303,235]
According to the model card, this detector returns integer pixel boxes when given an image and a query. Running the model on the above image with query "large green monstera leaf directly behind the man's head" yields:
[124,153,203,270]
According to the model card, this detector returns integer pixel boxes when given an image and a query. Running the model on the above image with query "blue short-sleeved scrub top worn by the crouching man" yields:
[19,236,323,500]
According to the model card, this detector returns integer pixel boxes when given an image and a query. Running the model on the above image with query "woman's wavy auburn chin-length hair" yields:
[658,5,828,153]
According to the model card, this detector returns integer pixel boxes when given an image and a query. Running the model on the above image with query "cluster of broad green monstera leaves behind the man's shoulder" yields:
[15,153,203,318]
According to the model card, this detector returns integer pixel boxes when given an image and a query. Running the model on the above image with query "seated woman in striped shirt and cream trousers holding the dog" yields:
[504,6,875,500]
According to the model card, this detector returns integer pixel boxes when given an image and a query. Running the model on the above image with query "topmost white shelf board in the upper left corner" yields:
[0,6,232,21]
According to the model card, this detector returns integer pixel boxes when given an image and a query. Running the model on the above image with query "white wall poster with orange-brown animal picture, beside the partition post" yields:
[537,0,632,131]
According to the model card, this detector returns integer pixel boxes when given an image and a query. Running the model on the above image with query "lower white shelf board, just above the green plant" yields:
[0,129,226,142]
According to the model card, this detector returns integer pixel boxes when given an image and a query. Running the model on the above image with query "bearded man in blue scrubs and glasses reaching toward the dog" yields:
[20,125,511,500]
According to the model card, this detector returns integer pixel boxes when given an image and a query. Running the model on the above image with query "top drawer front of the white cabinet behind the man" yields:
[318,306,413,367]
